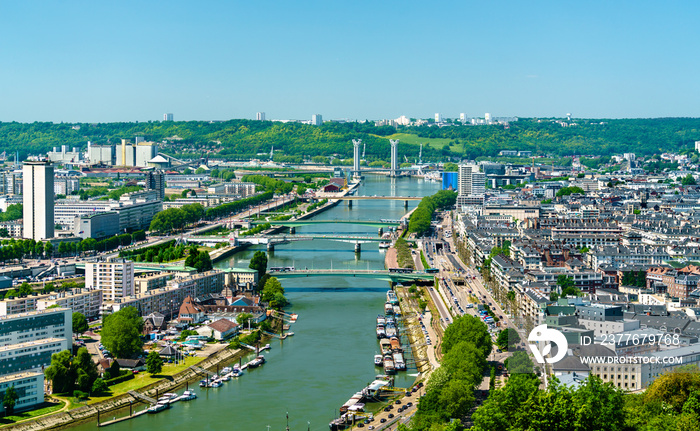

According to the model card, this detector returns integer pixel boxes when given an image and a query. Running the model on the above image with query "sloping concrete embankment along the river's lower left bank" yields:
[3,348,250,431]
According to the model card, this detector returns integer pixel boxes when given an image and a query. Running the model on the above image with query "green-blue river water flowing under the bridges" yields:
[78,175,439,431]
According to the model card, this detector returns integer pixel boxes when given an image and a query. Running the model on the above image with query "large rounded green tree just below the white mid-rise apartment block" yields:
[102,307,143,358]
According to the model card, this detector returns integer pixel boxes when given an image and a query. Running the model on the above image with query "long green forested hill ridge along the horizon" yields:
[0,118,700,161]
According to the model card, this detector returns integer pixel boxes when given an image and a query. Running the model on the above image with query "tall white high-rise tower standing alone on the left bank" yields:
[22,160,54,241]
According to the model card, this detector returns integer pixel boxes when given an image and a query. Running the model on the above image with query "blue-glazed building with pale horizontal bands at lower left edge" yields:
[0,308,73,410]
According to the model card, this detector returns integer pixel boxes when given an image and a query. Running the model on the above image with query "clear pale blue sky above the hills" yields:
[0,0,700,123]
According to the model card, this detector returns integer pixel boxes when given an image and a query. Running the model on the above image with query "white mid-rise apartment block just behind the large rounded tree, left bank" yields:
[85,258,134,301]
